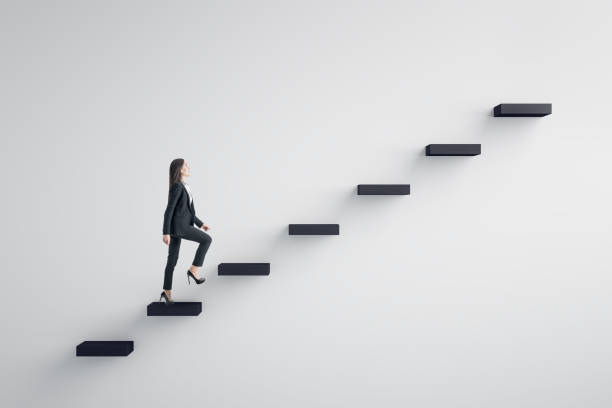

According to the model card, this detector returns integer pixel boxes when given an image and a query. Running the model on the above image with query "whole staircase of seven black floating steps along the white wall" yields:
[76,103,552,357]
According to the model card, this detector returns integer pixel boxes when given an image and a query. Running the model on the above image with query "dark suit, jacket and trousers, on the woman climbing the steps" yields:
[163,182,212,290]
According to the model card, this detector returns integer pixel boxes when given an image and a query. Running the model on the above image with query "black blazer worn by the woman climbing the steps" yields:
[163,182,203,235]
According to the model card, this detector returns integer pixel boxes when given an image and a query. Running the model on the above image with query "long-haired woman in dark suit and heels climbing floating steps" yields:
[159,159,212,303]
